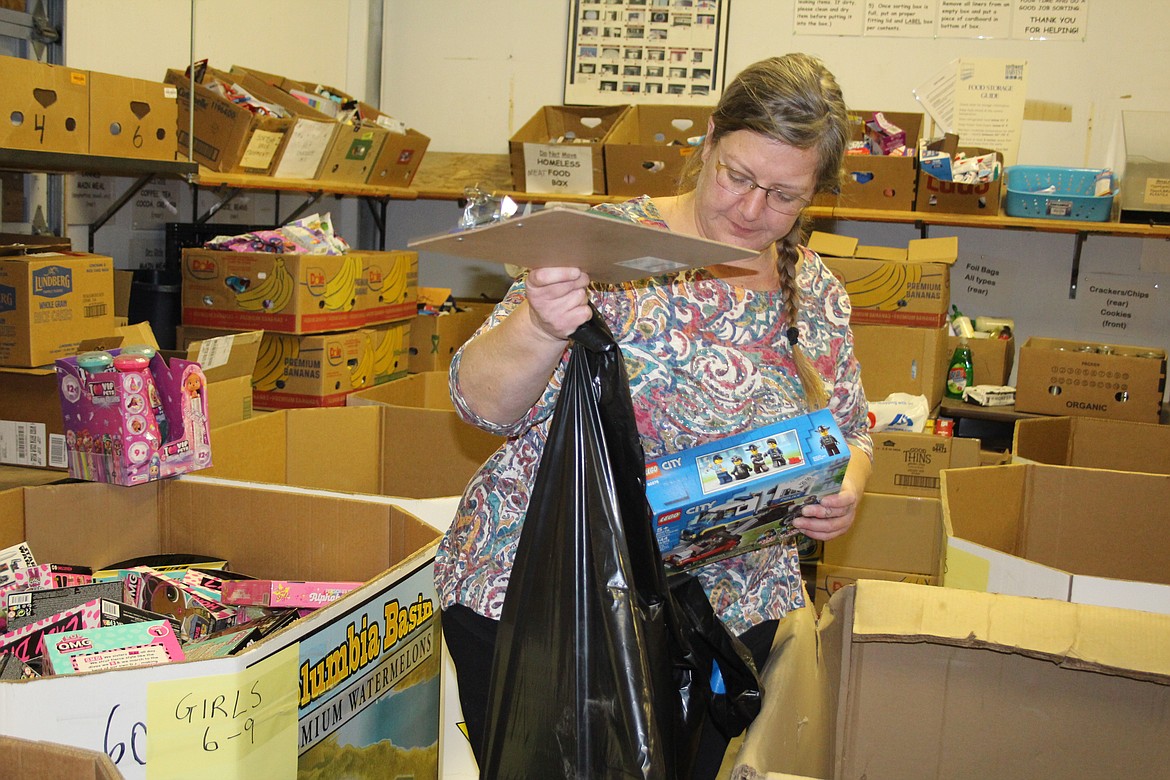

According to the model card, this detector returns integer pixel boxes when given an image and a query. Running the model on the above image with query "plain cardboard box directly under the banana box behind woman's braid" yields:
[853,325,952,408]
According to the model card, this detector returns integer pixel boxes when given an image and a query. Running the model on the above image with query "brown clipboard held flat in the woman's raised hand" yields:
[406,207,758,282]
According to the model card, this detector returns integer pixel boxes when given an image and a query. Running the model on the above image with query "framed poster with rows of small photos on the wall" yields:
[565,0,730,105]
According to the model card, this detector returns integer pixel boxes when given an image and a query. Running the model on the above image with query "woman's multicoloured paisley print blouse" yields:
[435,198,872,633]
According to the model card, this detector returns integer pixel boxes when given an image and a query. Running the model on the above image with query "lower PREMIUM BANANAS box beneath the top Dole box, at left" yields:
[252,329,376,409]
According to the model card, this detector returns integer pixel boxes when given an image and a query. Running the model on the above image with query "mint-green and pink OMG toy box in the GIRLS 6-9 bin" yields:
[44,620,184,675]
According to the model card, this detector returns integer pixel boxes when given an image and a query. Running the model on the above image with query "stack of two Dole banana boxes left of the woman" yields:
[180,249,418,409]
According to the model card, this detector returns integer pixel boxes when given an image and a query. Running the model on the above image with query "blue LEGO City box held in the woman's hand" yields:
[646,409,849,571]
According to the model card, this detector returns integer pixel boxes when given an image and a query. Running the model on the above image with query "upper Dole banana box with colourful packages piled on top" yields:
[183,249,418,334]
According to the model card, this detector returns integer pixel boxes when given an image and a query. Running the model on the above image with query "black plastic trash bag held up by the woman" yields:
[480,313,759,780]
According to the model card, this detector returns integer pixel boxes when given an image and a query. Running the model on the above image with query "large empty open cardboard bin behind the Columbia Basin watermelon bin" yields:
[204,399,503,498]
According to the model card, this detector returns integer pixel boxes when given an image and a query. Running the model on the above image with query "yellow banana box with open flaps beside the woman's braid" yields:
[808,230,958,327]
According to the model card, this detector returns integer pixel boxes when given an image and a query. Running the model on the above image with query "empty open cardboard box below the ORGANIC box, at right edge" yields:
[1012,417,1170,474]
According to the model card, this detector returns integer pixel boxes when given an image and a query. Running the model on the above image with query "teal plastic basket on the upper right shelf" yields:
[1004,165,1116,222]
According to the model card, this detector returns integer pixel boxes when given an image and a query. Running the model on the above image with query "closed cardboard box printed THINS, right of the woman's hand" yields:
[866,430,980,498]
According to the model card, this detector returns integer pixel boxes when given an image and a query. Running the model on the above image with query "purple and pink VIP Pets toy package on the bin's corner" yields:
[56,350,212,485]
